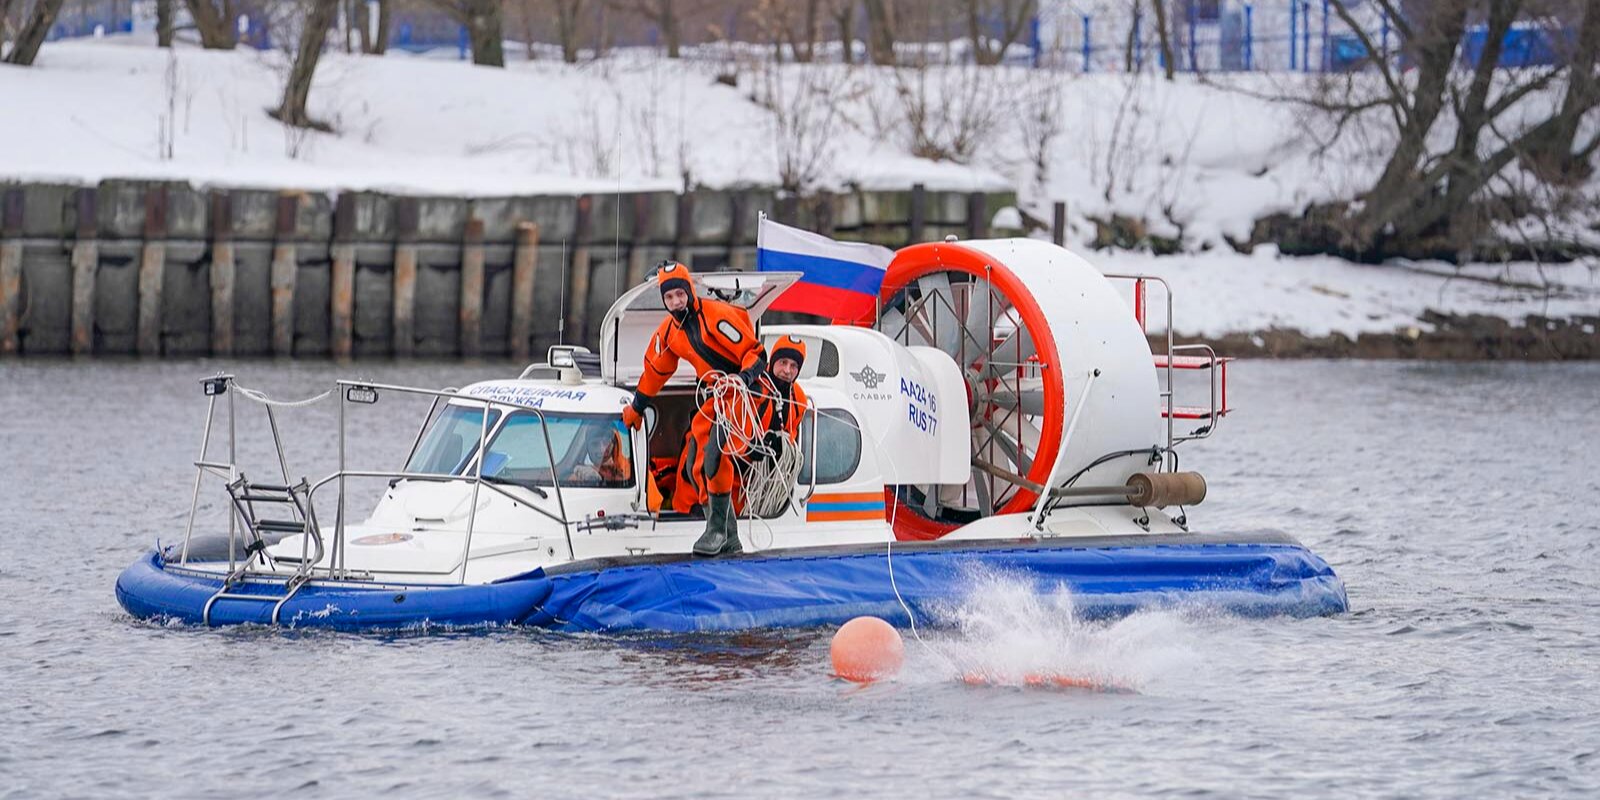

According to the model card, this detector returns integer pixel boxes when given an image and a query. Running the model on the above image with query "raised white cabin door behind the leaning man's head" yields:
[600,272,800,387]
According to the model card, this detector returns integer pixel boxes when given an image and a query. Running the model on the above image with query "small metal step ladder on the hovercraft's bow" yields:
[200,474,323,627]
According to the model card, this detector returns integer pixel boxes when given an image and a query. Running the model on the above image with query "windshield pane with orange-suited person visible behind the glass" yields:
[483,411,634,488]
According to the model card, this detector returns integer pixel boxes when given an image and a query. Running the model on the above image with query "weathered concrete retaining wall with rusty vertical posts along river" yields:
[0,181,1014,358]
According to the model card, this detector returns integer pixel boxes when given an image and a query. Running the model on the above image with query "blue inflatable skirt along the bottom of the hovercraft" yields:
[117,533,1347,632]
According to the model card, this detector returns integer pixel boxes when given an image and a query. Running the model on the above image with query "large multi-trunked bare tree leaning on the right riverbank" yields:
[1280,0,1600,258]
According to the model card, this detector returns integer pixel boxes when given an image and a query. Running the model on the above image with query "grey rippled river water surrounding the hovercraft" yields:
[0,362,1600,798]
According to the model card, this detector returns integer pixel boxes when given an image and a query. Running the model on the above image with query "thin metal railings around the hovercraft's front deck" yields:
[178,373,576,584]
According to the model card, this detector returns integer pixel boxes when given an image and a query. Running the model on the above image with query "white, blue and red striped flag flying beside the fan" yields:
[755,214,894,320]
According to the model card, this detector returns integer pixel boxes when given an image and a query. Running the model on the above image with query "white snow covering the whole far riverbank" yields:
[0,35,1600,334]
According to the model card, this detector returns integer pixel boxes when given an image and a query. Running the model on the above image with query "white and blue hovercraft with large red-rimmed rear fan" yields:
[117,238,1346,632]
